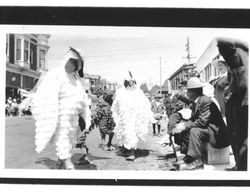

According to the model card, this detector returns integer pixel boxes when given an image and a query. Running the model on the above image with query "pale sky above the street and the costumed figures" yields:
[48,27,248,85]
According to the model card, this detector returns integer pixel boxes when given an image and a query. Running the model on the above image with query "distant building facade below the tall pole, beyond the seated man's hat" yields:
[168,63,196,93]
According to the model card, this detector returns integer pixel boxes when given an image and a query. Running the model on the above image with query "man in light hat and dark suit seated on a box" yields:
[172,77,228,170]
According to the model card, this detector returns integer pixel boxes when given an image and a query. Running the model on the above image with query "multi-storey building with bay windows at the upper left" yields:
[5,34,50,98]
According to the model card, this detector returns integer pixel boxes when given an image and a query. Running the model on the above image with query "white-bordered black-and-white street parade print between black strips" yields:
[0,4,250,186]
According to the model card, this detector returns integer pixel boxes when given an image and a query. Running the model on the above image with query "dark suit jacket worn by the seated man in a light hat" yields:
[185,95,229,148]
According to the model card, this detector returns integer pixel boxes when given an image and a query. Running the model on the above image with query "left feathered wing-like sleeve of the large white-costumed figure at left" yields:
[32,71,61,153]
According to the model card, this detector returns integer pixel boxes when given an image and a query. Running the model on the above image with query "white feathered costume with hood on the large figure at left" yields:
[32,47,90,160]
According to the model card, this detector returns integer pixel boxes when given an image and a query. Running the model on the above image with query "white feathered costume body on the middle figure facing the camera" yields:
[111,82,152,149]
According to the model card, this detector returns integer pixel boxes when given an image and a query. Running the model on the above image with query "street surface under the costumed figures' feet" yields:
[5,116,234,171]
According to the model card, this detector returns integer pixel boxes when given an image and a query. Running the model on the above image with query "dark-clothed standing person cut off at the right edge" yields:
[216,38,248,171]
